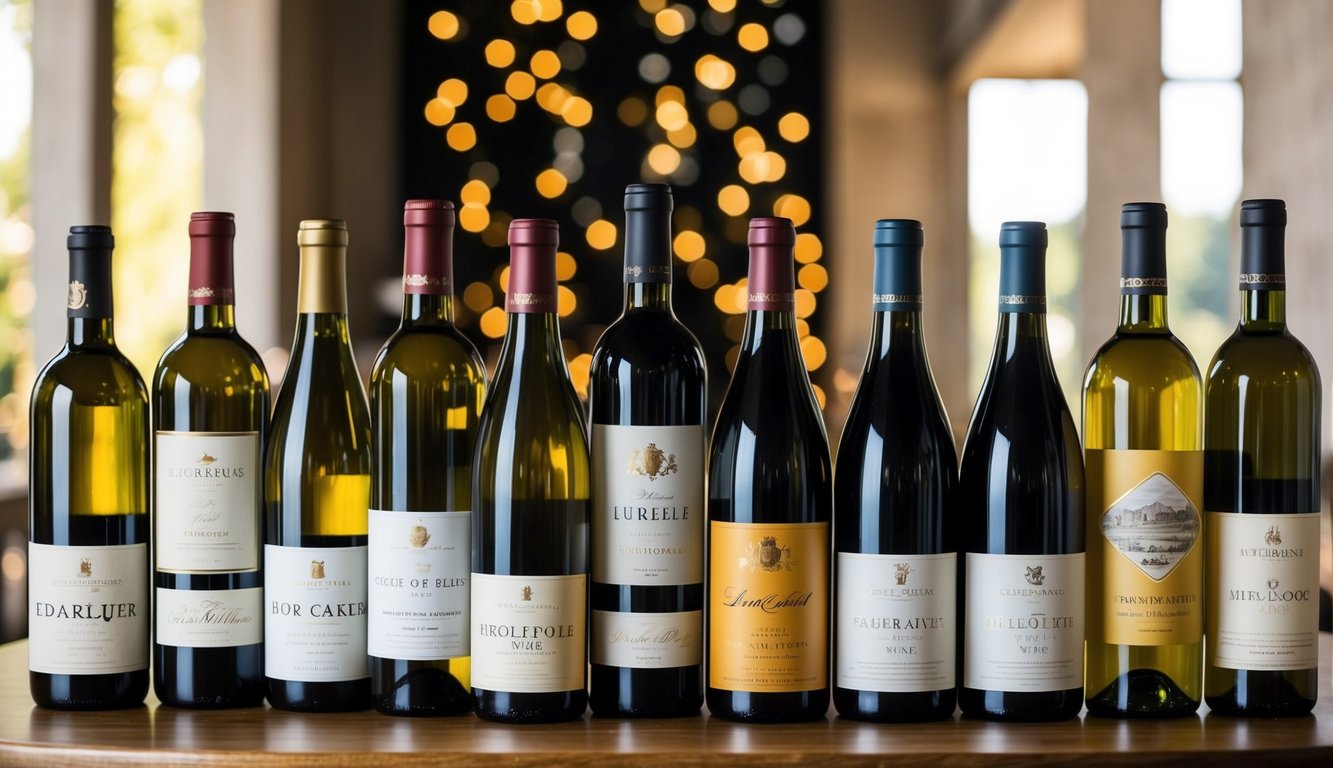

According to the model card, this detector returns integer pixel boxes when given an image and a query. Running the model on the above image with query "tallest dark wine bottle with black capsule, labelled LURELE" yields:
[588,184,708,717]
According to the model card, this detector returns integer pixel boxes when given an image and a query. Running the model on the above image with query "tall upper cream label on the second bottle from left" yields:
[153,432,260,573]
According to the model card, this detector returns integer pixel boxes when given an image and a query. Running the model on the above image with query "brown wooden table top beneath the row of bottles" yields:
[0,635,1333,768]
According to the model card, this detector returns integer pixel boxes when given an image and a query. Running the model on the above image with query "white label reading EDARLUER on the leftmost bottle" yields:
[28,544,148,675]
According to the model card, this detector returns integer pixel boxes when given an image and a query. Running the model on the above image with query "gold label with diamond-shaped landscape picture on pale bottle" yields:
[1086,449,1204,645]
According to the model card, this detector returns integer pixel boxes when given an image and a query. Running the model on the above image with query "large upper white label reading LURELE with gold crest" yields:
[592,424,705,585]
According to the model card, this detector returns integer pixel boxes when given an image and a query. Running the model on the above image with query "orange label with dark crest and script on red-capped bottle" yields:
[708,521,829,693]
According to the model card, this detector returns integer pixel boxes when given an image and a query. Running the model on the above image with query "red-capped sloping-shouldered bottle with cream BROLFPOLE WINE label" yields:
[472,219,592,723]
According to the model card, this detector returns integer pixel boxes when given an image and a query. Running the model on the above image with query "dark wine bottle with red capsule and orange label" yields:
[705,217,833,723]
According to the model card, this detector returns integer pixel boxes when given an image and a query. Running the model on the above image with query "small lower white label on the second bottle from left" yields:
[156,587,264,648]
